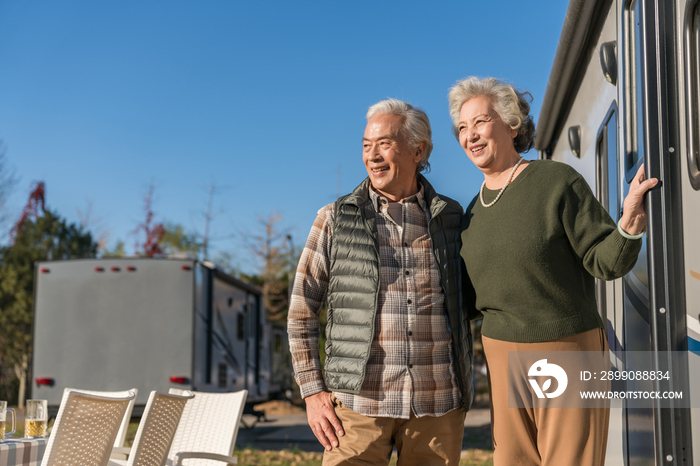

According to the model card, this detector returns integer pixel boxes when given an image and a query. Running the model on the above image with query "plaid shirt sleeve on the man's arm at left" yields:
[287,204,334,398]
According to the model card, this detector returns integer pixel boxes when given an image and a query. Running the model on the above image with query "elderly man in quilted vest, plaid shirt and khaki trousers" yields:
[288,99,473,465]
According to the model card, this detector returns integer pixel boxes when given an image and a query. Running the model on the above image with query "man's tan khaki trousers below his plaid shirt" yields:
[323,396,465,466]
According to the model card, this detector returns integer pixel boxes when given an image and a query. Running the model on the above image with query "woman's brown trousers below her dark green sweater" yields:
[482,329,610,466]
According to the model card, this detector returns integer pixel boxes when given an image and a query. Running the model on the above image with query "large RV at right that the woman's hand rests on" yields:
[535,0,700,465]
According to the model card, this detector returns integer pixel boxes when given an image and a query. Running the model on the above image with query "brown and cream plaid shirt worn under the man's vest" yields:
[288,186,461,419]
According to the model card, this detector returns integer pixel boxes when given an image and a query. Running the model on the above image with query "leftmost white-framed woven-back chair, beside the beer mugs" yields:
[41,388,136,466]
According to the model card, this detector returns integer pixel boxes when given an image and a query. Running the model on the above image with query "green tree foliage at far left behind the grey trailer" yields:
[0,210,98,398]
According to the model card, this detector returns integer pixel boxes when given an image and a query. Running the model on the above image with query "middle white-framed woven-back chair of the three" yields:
[109,391,194,466]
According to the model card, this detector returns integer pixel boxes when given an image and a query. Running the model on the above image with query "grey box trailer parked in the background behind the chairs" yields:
[31,258,292,412]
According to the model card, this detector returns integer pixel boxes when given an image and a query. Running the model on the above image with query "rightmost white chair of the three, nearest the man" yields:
[165,388,248,466]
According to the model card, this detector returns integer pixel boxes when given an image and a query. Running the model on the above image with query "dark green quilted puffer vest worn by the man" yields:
[324,175,474,410]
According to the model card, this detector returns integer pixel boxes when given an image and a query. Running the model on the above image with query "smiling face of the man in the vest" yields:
[362,115,424,201]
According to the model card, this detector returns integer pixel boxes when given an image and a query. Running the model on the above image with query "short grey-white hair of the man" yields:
[367,99,433,173]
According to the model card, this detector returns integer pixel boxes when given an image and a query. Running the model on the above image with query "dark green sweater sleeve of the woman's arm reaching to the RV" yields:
[559,175,642,280]
